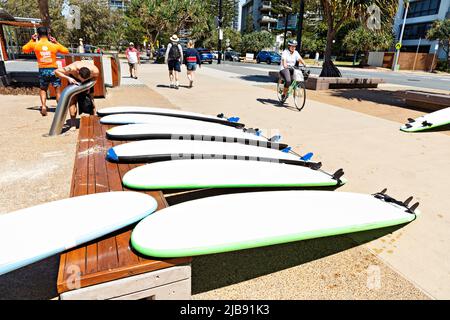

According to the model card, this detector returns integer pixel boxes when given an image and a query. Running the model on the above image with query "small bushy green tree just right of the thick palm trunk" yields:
[343,26,394,66]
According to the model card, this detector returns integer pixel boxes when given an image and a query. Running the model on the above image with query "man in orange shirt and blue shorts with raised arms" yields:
[22,27,69,116]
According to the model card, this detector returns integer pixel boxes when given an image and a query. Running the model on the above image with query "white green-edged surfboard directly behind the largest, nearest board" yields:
[122,159,346,190]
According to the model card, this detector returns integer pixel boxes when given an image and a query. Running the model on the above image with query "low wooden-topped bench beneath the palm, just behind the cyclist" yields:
[269,71,384,90]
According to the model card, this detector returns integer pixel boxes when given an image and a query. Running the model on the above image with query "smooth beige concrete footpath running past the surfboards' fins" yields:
[134,65,450,299]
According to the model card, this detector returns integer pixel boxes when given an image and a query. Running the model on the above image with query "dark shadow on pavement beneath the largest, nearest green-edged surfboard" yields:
[192,226,402,294]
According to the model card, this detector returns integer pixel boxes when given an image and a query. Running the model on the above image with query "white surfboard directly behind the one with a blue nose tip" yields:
[106,124,287,149]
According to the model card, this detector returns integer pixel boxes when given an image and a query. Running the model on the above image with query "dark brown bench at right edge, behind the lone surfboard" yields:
[395,90,450,111]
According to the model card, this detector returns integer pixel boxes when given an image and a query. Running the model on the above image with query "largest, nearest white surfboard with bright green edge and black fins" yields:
[131,191,419,258]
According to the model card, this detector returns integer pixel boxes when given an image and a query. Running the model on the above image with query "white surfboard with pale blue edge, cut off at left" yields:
[0,191,157,274]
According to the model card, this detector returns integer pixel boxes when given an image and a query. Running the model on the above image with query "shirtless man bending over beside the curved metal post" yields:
[55,61,100,129]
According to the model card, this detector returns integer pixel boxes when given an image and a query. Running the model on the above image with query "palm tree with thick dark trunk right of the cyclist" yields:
[320,0,398,77]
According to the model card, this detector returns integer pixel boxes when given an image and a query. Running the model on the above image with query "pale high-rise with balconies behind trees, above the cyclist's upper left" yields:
[241,0,278,32]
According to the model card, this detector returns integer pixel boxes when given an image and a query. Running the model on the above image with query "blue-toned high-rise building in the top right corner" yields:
[394,0,450,59]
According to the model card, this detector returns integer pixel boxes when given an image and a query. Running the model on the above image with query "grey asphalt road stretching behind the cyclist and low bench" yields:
[207,61,450,91]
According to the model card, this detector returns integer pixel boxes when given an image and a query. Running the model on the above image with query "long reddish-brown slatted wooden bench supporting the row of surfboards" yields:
[57,116,191,299]
